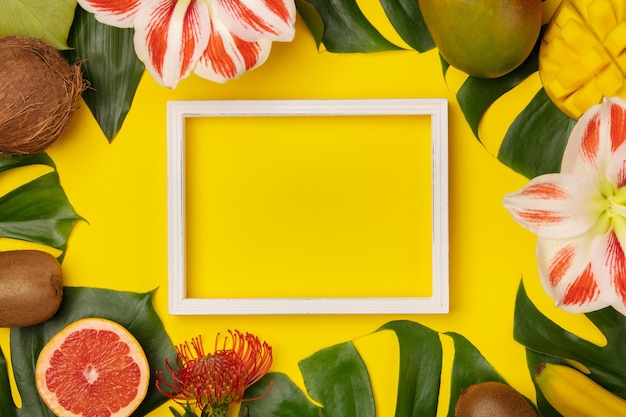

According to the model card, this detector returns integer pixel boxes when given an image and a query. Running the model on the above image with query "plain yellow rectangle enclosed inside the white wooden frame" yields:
[185,116,432,298]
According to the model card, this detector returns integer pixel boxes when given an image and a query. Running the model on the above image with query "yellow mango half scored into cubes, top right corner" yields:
[539,0,626,119]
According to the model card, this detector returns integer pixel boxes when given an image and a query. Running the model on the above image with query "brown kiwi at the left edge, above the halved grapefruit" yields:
[0,249,63,327]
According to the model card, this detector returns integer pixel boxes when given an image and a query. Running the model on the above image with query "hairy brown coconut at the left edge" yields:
[0,35,84,156]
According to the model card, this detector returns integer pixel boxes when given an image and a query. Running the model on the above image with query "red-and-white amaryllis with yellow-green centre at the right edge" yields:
[504,97,626,314]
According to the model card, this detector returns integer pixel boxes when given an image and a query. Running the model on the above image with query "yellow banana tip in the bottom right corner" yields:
[535,363,626,417]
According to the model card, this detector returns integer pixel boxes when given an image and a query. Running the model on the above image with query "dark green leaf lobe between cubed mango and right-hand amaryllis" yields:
[498,88,576,178]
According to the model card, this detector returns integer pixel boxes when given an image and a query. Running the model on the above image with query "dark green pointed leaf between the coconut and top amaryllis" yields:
[65,7,144,142]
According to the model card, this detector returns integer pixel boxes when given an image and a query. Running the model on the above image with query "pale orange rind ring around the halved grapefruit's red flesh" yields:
[35,318,150,417]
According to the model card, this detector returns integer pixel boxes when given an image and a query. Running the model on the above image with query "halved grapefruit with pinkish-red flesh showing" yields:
[35,318,150,417]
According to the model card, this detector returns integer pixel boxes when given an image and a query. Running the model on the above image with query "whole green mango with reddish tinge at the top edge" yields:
[419,0,542,78]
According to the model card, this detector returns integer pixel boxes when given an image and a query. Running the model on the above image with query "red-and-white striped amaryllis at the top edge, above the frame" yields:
[78,0,296,88]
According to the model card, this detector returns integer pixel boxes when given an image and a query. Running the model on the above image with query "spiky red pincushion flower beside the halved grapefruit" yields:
[156,330,273,417]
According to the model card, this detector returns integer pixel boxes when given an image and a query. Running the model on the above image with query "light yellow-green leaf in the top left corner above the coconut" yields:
[0,0,76,50]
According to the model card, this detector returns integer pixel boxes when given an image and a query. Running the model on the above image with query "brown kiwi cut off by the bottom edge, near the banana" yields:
[454,381,537,417]
